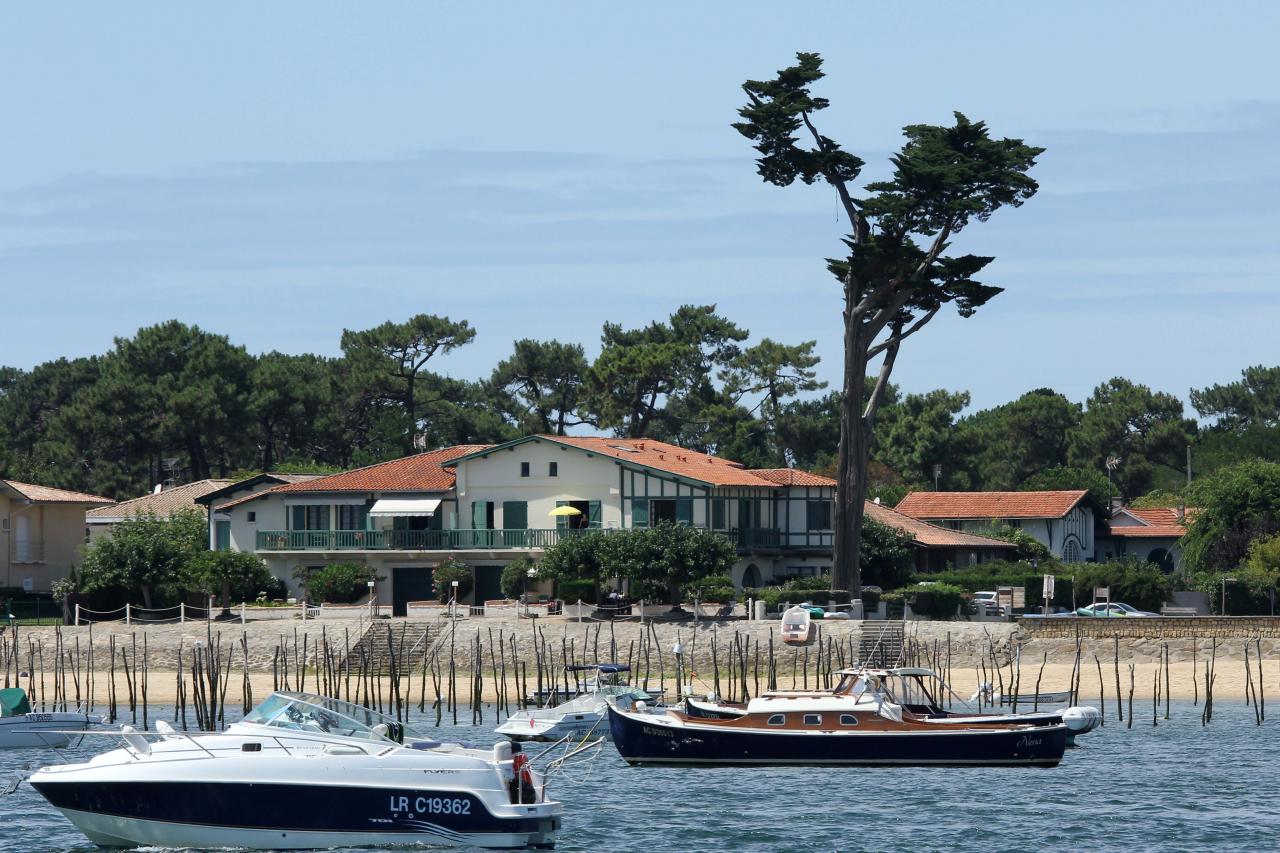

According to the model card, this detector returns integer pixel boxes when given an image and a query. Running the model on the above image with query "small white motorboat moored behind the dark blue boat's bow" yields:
[494,663,662,740]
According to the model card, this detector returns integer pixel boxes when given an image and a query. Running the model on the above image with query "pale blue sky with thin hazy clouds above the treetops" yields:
[0,0,1280,409]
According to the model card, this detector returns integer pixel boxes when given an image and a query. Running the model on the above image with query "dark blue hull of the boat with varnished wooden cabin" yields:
[609,707,1068,767]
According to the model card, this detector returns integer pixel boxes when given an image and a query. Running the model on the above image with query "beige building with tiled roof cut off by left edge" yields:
[0,480,113,592]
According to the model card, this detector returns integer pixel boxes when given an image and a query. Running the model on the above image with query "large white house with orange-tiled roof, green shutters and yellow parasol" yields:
[211,435,835,613]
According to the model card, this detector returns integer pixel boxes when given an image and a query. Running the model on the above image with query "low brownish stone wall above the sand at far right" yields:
[1018,616,1280,639]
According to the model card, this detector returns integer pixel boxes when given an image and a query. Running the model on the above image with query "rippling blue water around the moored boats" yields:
[0,702,1280,853]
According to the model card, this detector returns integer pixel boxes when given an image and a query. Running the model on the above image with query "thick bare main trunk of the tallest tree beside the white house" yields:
[831,303,870,598]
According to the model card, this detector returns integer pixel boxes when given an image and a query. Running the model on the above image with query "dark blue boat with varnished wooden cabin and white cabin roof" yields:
[609,704,1068,767]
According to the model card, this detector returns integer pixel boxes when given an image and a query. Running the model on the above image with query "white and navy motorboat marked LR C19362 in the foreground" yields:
[28,693,563,850]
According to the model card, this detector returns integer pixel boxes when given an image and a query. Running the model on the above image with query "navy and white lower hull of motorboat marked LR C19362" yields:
[31,779,559,850]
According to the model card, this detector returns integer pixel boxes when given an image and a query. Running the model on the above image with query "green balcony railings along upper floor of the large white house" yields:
[257,528,832,552]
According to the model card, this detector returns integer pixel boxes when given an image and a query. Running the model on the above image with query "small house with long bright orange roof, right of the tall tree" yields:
[896,489,1105,562]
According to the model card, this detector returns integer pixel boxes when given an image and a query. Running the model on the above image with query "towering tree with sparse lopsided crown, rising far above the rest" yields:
[733,53,1043,594]
